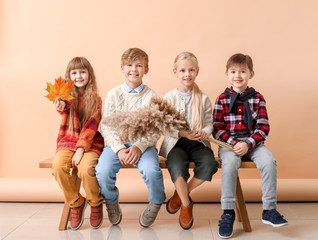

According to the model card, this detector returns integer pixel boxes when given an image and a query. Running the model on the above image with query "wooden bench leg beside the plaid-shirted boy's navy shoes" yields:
[236,177,252,232]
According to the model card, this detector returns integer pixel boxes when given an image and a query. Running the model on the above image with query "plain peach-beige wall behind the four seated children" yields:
[0,0,318,201]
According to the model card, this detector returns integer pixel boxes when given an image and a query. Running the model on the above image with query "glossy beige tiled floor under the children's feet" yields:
[0,203,318,240]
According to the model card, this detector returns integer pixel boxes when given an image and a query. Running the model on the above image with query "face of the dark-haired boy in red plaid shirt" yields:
[225,64,254,93]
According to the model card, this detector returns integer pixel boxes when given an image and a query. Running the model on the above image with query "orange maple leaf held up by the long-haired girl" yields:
[46,77,74,102]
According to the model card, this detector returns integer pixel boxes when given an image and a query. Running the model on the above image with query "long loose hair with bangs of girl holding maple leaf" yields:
[65,57,100,131]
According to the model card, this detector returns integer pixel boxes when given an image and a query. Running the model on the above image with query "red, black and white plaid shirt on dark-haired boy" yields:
[212,88,269,149]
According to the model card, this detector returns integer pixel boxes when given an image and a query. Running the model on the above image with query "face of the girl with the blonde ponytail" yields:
[173,59,199,92]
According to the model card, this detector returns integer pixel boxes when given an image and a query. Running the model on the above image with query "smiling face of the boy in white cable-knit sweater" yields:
[121,58,148,88]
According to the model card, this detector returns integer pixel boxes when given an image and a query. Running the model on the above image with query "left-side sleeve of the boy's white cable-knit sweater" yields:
[100,92,126,153]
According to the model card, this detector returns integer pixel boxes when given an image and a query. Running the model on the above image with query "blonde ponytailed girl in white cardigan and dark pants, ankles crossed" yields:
[160,52,218,229]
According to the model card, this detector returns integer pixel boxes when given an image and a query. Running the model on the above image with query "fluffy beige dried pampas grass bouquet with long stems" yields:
[102,98,233,150]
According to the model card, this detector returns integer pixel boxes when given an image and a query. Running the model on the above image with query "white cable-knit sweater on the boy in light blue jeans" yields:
[101,84,158,153]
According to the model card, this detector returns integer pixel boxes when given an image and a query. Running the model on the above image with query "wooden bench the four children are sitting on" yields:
[39,156,256,232]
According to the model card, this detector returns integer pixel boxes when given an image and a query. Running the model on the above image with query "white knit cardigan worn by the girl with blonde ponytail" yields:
[159,89,212,157]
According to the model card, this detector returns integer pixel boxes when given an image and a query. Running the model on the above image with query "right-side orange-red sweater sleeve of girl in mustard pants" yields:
[76,98,102,152]
